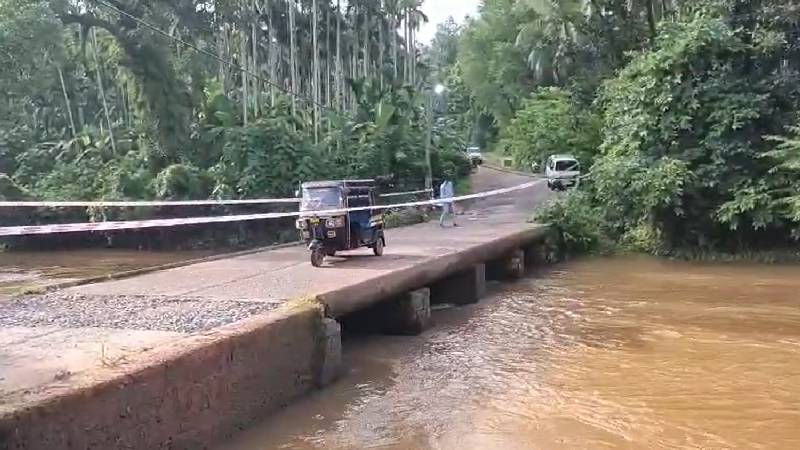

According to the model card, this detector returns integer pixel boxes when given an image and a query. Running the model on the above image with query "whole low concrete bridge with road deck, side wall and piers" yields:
[0,169,548,449]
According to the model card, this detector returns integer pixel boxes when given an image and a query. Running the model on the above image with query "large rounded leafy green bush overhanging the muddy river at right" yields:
[596,9,800,250]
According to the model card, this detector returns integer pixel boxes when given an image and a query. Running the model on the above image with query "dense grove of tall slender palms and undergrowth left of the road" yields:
[0,0,473,206]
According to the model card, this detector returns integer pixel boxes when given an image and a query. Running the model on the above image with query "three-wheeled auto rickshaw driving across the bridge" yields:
[297,180,386,267]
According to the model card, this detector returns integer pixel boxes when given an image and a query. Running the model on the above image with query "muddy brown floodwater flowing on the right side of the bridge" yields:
[220,258,800,450]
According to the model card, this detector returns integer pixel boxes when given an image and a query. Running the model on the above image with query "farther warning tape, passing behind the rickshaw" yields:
[0,189,433,208]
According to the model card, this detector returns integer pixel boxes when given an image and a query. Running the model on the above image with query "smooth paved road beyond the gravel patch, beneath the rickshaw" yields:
[70,168,548,302]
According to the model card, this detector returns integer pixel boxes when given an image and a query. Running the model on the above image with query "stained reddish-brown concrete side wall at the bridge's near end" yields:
[0,299,336,450]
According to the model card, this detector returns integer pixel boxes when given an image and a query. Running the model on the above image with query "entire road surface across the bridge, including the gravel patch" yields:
[0,168,549,410]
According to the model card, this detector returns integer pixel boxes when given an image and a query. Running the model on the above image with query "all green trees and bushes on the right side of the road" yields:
[450,0,800,255]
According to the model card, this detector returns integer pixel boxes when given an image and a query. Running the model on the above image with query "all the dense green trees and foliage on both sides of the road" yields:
[6,0,800,254]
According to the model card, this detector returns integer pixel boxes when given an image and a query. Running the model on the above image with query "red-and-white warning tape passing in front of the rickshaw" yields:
[0,180,543,236]
